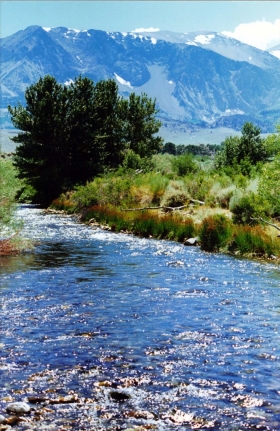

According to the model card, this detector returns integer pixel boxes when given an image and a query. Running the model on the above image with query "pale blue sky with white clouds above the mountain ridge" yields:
[0,0,280,49]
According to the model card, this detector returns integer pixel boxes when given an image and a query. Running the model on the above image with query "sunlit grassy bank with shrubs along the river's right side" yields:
[51,155,280,261]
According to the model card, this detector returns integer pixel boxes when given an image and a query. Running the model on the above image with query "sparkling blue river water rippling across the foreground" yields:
[0,206,280,431]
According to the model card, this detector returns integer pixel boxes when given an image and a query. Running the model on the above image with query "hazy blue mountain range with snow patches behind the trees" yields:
[0,26,280,143]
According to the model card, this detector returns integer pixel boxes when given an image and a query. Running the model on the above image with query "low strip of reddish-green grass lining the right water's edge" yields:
[46,205,280,263]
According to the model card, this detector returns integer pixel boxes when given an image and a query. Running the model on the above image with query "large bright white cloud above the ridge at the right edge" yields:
[222,19,280,50]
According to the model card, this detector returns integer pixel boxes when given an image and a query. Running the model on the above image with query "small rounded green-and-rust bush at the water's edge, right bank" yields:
[199,214,232,251]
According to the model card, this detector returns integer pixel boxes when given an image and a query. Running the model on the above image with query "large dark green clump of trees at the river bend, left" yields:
[8,76,162,205]
